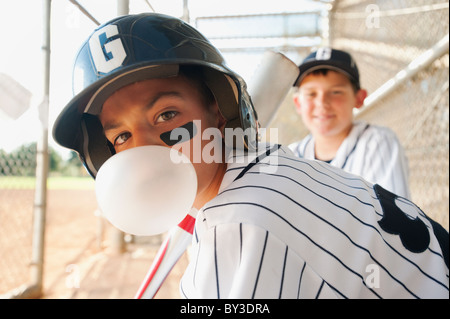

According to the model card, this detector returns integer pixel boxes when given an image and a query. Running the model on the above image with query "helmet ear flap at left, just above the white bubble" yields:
[81,113,116,178]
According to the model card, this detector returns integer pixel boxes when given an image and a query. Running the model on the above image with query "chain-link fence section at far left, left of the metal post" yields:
[0,144,36,294]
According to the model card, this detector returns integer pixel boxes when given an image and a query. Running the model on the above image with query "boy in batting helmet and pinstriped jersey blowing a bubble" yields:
[53,13,449,298]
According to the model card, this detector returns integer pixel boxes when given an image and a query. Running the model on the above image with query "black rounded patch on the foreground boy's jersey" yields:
[374,185,430,253]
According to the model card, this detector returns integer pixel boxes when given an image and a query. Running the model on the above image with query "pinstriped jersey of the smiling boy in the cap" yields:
[289,122,411,199]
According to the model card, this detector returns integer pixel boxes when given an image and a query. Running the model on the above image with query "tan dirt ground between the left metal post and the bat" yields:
[0,190,187,299]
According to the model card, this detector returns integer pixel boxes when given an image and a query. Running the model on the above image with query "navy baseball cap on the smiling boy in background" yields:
[294,47,360,88]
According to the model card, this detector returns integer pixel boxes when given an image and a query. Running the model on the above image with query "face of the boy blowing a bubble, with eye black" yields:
[100,76,225,210]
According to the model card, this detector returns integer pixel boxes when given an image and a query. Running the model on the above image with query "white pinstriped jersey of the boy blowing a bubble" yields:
[180,146,449,298]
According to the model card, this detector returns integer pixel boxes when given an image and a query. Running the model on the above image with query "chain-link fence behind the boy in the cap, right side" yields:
[272,0,449,230]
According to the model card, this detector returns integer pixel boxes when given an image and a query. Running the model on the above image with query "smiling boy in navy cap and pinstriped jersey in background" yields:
[289,47,410,199]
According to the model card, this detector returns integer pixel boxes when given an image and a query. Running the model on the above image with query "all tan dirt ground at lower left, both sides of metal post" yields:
[0,189,446,299]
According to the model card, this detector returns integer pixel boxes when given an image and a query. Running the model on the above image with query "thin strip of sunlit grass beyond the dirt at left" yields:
[0,176,95,190]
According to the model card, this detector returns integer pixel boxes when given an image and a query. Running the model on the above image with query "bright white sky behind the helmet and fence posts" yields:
[0,0,324,153]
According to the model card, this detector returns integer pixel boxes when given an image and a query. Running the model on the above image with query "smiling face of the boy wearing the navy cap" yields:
[294,70,367,137]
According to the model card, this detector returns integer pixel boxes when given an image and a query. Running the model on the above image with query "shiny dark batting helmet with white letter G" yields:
[53,13,258,178]
